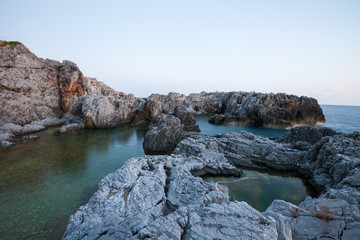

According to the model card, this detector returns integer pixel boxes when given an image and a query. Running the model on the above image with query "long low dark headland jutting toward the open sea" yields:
[141,92,325,128]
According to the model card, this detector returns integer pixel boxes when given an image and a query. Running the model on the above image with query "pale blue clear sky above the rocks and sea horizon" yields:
[0,0,360,105]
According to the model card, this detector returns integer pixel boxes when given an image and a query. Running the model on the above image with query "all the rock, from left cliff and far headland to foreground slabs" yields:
[0,41,360,239]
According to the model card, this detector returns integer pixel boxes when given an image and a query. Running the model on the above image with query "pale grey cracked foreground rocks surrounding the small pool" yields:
[63,127,360,239]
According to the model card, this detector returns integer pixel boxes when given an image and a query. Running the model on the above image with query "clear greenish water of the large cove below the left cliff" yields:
[0,126,147,240]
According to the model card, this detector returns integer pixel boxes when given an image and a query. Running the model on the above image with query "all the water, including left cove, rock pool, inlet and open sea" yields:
[0,105,360,240]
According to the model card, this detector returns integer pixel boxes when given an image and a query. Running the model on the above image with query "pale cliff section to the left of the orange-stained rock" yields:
[0,44,62,126]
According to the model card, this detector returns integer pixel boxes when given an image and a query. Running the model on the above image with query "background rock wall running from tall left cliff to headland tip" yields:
[0,41,325,148]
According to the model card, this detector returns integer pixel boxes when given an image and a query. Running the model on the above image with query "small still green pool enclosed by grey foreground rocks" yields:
[204,170,314,212]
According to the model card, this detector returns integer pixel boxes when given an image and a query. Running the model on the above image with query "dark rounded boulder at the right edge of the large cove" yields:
[143,113,200,154]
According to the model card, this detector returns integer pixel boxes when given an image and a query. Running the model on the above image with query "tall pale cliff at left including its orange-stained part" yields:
[0,42,118,126]
